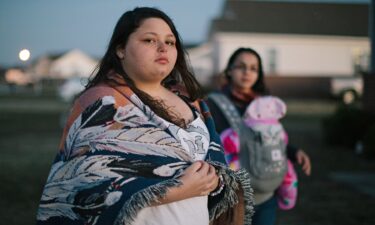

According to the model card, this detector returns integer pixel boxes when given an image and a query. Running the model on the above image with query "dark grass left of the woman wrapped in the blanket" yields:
[0,96,67,225]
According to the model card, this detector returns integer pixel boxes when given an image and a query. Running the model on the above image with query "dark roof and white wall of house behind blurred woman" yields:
[190,0,370,86]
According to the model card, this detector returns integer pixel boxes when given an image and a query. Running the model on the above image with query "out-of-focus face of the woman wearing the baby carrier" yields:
[229,52,259,92]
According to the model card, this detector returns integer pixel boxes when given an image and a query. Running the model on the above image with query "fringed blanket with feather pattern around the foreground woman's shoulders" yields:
[37,81,253,224]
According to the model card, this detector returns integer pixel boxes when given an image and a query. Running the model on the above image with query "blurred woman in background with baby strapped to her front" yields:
[207,48,311,225]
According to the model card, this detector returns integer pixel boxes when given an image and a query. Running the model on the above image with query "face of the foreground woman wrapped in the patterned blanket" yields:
[117,18,177,87]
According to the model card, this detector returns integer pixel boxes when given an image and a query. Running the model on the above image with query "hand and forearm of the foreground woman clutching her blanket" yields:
[153,161,219,205]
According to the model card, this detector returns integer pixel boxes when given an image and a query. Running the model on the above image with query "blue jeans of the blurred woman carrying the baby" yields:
[252,195,277,225]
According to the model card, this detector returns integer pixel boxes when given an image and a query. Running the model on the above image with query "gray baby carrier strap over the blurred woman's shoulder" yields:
[208,93,242,136]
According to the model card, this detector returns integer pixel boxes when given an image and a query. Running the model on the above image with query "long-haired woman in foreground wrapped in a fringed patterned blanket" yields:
[37,7,252,225]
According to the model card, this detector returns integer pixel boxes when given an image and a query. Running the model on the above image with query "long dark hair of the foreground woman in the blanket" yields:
[85,7,202,125]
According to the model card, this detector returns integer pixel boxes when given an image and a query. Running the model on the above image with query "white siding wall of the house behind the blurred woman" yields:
[211,33,370,76]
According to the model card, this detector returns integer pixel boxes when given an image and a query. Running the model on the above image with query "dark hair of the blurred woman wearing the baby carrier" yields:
[224,48,268,94]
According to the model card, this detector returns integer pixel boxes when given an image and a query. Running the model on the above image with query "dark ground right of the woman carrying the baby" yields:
[277,101,375,225]
